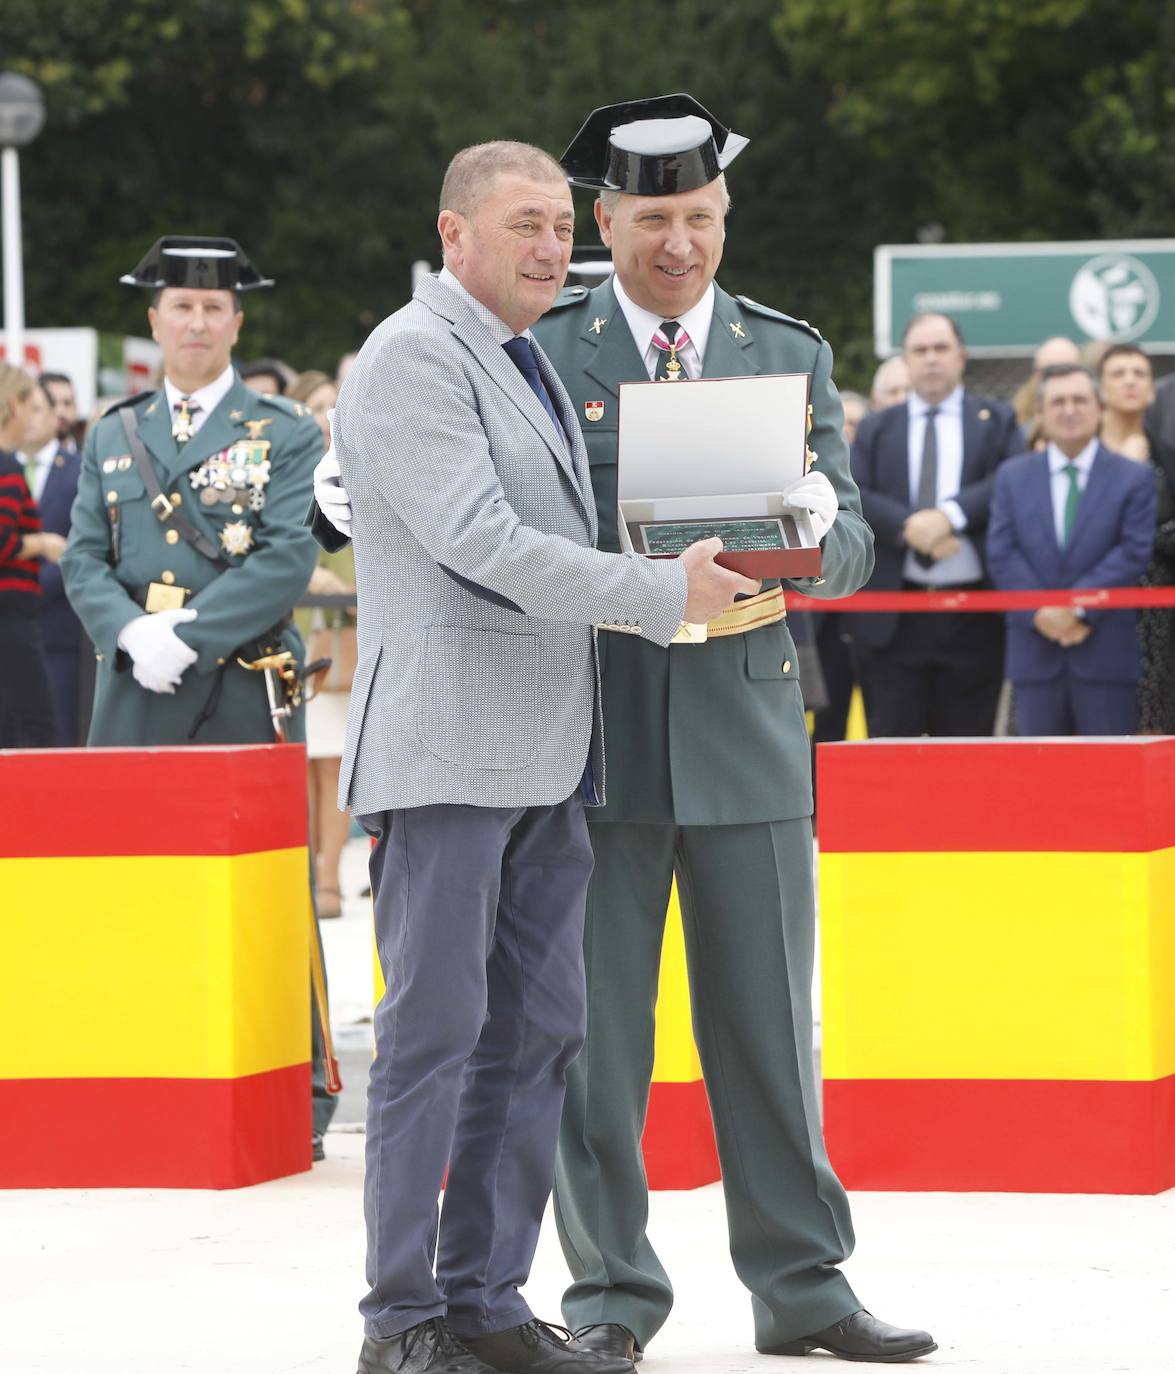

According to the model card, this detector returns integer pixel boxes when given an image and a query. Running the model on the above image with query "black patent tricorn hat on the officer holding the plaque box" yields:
[559,92,749,195]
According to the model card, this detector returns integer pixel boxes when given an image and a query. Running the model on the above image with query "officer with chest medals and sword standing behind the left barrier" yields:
[60,235,334,1157]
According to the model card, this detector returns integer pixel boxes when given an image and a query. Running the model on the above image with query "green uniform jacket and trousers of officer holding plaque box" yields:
[535,280,873,1348]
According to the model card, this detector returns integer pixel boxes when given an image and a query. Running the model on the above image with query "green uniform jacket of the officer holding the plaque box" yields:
[533,279,873,826]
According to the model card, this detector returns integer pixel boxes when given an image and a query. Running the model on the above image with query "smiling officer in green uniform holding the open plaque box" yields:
[312,95,936,1363]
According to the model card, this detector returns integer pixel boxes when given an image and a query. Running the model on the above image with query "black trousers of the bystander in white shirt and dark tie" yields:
[860,583,1003,738]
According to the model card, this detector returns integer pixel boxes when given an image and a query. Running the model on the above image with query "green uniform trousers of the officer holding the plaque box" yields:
[555,816,860,1347]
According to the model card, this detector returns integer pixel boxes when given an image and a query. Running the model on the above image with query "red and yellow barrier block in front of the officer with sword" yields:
[0,745,311,1189]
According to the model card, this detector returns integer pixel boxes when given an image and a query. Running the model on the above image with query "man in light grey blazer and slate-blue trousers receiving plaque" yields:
[333,143,757,1374]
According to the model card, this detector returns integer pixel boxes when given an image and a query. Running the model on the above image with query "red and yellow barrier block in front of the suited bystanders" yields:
[818,738,1175,1193]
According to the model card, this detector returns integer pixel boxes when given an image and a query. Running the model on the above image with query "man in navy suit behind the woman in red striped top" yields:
[25,379,84,747]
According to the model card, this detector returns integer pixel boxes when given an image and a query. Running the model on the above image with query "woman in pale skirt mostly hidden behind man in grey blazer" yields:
[286,372,359,919]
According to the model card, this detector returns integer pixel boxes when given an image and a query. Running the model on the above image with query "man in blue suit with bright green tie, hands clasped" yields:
[987,363,1157,735]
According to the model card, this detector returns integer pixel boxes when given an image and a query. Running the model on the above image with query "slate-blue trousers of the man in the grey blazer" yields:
[360,794,592,1337]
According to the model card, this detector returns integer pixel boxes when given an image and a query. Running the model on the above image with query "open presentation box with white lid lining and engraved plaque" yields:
[617,372,820,577]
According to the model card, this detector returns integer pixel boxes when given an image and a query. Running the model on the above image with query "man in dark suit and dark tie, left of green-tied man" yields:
[849,315,1020,736]
